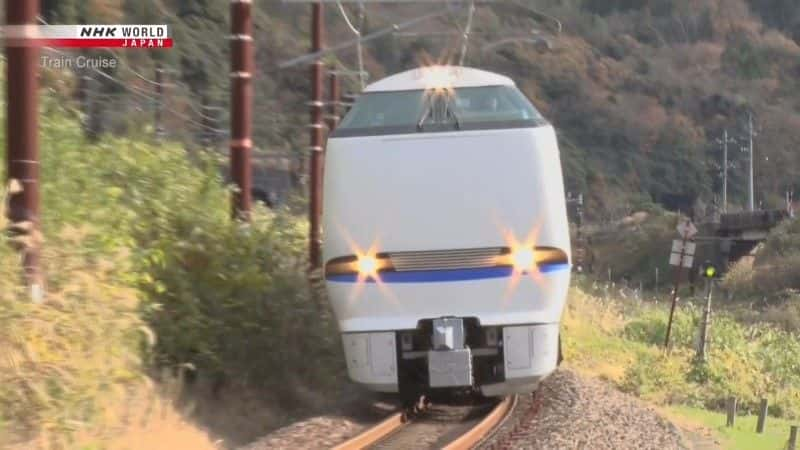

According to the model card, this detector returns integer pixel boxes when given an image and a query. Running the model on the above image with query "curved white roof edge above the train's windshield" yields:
[364,66,514,92]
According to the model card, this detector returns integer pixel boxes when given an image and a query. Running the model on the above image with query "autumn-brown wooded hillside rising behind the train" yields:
[39,0,800,219]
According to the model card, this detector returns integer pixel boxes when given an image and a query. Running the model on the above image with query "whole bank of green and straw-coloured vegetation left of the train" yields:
[0,99,342,449]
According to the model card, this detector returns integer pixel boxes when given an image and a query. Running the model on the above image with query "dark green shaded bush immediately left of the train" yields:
[142,212,343,385]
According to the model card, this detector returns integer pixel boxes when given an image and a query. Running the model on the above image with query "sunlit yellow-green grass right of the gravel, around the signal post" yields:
[563,280,800,448]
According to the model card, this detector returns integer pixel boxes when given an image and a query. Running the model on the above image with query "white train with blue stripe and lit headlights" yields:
[323,66,570,396]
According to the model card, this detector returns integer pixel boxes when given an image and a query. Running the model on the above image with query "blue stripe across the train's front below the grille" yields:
[326,264,570,283]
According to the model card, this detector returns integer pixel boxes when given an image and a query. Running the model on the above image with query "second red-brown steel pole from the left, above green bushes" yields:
[230,0,254,220]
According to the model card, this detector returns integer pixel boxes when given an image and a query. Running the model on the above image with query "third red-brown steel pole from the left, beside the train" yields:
[308,2,324,270]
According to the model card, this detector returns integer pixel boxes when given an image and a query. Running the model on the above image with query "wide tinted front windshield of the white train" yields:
[334,86,544,137]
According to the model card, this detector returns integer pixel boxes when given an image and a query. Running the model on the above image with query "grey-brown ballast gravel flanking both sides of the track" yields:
[240,370,690,450]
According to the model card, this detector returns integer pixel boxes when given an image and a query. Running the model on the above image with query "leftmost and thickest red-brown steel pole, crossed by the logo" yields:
[6,0,42,298]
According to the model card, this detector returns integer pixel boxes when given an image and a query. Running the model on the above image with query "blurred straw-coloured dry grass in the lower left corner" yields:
[0,184,218,450]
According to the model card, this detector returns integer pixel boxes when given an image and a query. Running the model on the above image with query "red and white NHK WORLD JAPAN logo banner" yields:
[3,25,173,49]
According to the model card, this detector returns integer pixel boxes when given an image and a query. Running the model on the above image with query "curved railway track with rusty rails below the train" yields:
[335,396,517,450]
